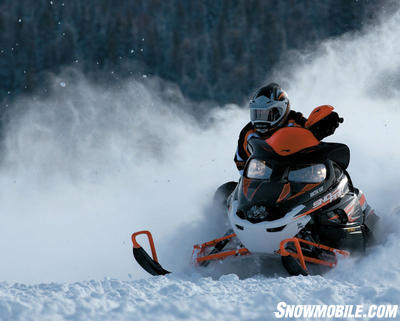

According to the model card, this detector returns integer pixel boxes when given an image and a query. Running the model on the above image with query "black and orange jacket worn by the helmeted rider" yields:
[234,110,307,174]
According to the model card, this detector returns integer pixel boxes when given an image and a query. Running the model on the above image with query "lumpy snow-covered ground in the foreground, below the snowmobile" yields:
[0,236,400,320]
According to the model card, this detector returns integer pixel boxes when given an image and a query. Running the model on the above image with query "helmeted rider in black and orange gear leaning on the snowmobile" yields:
[234,83,343,174]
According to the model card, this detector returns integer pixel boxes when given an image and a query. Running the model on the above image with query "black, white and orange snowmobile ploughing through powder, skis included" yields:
[132,107,379,275]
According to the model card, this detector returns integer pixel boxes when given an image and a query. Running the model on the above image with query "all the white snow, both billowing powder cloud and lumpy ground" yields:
[0,8,400,320]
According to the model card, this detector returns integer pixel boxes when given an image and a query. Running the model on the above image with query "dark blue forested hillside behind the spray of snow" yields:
[0,0,383,103]
